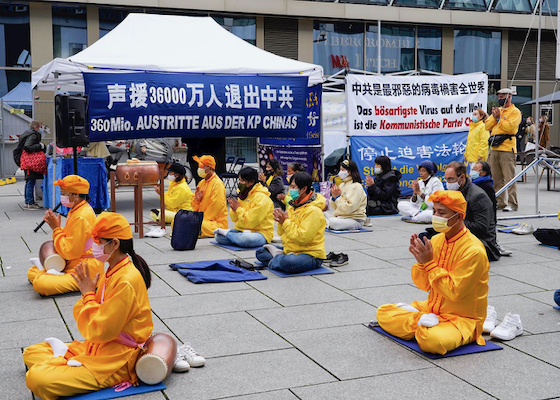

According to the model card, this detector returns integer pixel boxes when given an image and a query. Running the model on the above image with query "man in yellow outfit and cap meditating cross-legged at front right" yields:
[377,191,490,355]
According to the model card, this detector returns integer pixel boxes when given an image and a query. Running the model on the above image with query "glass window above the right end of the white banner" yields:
[453,29,502,79]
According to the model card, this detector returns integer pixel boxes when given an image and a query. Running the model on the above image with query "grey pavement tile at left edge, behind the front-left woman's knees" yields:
[0,316,70,350]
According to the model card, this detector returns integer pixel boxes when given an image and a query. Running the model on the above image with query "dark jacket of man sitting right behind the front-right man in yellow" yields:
[461,178,500,261]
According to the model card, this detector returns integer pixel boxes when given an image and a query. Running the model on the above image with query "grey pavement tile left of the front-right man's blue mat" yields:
[282,325,431,379]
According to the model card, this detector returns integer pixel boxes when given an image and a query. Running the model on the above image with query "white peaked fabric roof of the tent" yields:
[32,13,323,91]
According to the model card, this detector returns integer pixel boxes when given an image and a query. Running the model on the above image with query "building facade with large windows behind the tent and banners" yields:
[0,0,560,158]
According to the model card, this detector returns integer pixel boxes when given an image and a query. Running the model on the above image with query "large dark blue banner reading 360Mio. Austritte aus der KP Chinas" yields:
[83,72,308,142]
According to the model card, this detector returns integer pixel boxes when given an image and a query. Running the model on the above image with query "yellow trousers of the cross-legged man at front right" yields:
[377,301,474,355]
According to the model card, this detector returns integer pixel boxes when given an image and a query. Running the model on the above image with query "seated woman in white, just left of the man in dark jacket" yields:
[398,160,444,224]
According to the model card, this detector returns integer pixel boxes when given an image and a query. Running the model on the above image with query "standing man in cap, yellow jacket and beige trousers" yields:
[486,88,521,211]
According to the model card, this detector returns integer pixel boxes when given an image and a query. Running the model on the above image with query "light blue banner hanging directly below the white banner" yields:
[350,132,468,195]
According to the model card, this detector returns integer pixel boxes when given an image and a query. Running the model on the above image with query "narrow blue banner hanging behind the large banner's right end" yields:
[259,85,323,146]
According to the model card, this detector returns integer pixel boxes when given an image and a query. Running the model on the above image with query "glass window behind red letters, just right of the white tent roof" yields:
[313,21,364,75]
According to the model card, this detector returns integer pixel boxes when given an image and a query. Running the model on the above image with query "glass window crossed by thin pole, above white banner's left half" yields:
[366,23,414,73]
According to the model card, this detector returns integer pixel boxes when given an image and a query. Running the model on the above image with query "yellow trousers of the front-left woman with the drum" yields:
[23,342,123,400]
